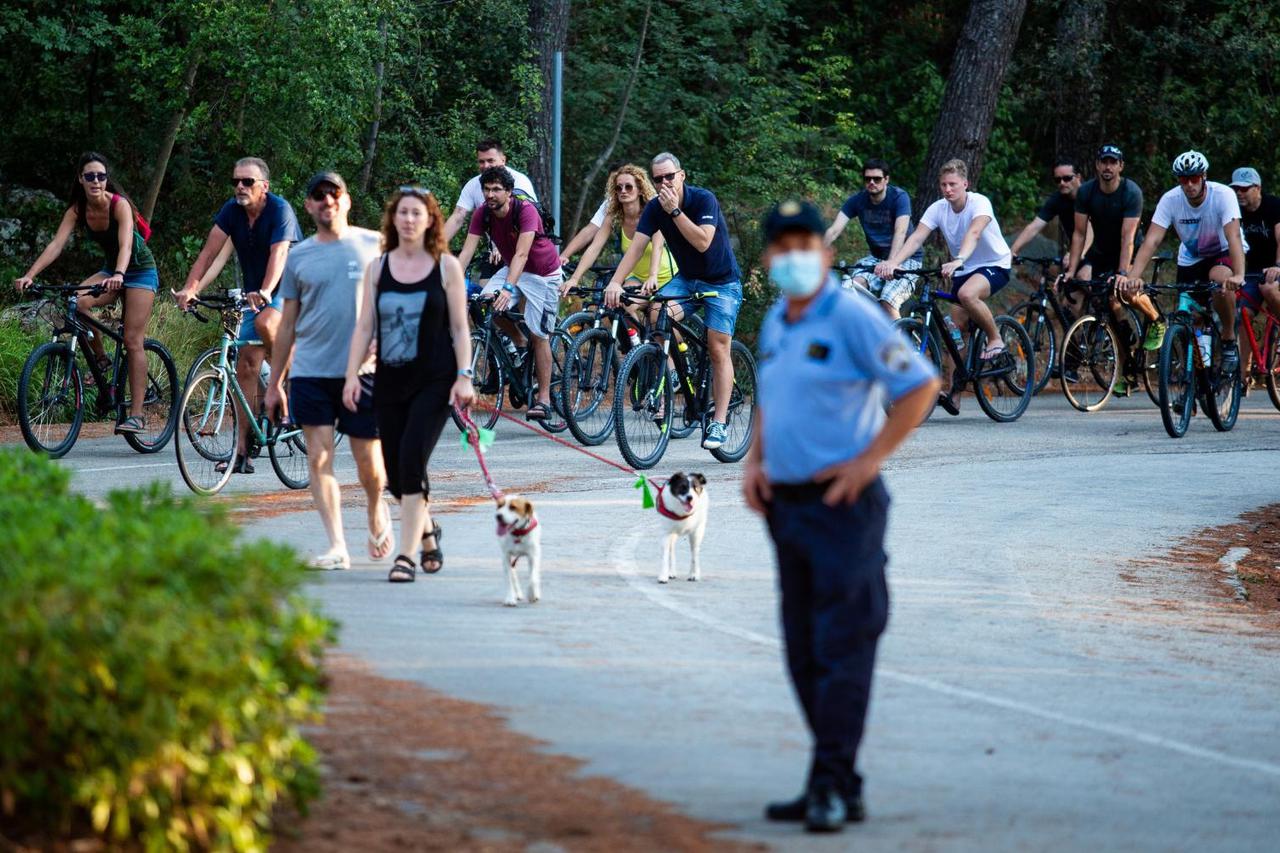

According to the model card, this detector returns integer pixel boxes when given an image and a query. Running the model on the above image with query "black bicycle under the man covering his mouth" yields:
[613,291,756,470]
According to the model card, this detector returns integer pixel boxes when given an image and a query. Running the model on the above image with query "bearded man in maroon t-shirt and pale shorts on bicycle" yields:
[458,167,564,420]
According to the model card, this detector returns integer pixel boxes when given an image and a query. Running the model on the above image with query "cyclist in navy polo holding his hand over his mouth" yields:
[604,151,742,450]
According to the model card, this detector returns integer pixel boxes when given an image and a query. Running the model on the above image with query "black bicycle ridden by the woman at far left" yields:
[18,283,178,459]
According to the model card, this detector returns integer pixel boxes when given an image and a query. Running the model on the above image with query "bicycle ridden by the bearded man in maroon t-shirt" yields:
[451,293,572,433]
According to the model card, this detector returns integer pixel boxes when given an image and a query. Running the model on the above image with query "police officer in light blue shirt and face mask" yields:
[742,201,938,833]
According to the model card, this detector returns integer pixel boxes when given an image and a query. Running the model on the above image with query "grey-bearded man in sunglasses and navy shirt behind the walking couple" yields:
[175,158,302,474]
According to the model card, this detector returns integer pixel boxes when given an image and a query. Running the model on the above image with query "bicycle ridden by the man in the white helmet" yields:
[1152,282,1242,438]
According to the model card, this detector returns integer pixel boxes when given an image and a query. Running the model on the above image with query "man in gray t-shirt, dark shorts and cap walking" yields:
[266,172,392,569]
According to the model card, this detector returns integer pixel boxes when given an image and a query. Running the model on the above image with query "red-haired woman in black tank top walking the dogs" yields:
[342,186,475,583]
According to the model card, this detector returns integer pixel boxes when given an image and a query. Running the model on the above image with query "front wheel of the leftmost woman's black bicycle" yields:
[18,341,84,459]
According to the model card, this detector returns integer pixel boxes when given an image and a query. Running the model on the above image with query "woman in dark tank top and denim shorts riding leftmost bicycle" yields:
[14,151,160,433]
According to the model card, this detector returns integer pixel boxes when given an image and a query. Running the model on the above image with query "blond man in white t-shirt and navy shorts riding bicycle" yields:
[876,160,1012,415]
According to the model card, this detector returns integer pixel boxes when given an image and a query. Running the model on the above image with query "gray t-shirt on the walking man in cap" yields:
[280,228,381,379]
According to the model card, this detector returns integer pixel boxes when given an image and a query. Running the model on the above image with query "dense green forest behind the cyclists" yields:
[0,0,1280,302]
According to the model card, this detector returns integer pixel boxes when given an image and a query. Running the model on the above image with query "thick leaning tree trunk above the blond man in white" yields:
[914,0,1027,218]
